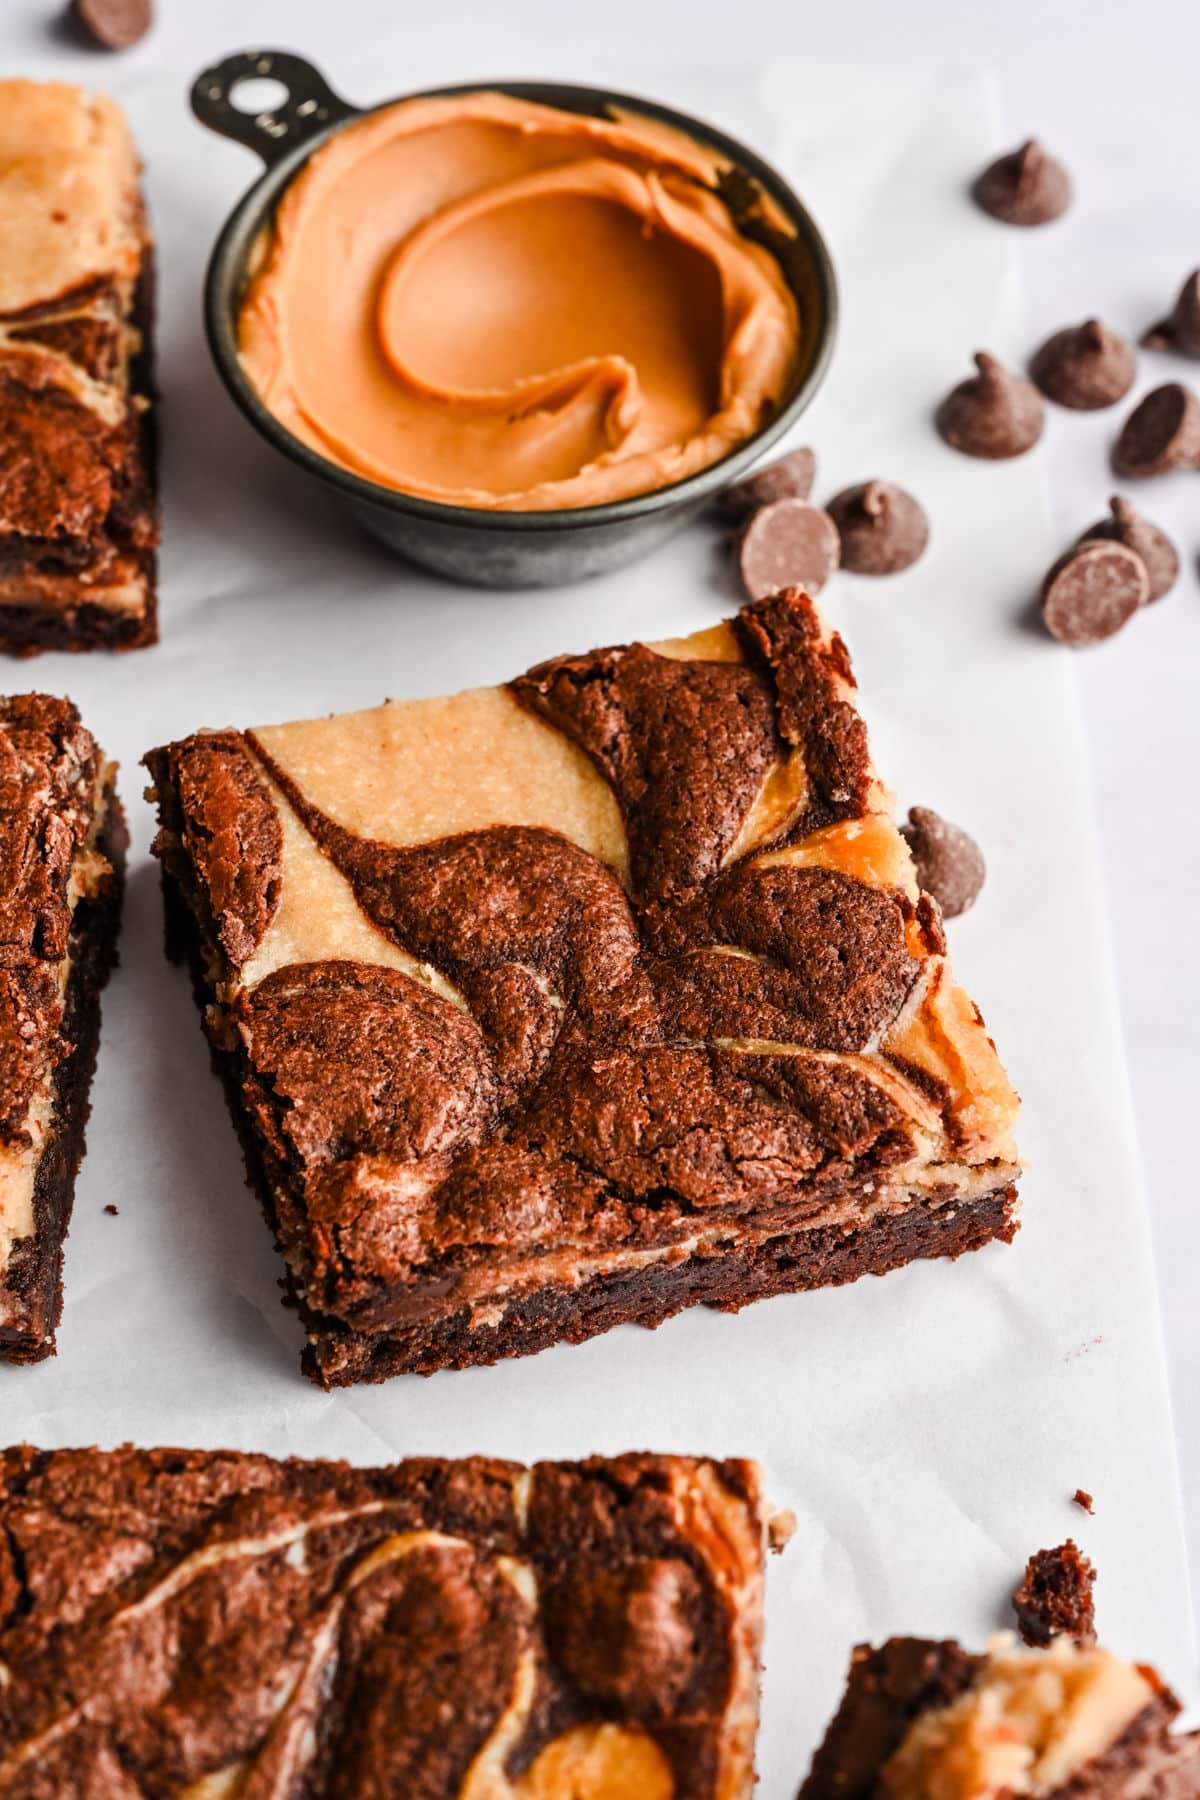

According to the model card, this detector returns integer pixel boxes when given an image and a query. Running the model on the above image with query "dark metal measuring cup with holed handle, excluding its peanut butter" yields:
[191,50,837,587]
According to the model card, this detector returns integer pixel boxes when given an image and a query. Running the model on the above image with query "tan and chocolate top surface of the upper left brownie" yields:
[0,81,153,554]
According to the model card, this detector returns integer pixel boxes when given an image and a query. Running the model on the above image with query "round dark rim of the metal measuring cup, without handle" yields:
[203,79,838,533]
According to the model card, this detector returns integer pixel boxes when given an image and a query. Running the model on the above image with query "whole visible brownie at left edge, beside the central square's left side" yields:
[0,693,126,1363]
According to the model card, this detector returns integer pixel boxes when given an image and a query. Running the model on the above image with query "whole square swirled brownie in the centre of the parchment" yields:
[148,590,1018,1384]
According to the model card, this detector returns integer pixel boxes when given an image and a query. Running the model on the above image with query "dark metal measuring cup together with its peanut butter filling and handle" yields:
[193,50,837,587]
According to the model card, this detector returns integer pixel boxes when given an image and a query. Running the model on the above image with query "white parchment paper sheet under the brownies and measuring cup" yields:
[0,45,1193,1800]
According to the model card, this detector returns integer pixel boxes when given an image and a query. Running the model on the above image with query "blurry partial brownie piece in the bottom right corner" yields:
[799,1633,1200,1800]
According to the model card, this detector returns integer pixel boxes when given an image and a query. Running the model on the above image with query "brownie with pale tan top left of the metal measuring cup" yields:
[0,81,158,655]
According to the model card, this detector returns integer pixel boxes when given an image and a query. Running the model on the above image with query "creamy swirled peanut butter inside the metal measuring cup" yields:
[239,92,799,511]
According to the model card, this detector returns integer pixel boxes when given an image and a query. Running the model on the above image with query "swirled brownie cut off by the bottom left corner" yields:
[0,1447,763,1800]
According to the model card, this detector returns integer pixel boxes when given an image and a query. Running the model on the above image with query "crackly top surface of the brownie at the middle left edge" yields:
[0,693,106,1276]
